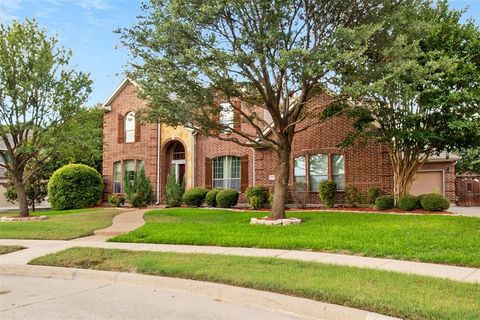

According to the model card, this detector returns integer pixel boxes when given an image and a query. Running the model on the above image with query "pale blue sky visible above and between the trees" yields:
[0,0,480,105]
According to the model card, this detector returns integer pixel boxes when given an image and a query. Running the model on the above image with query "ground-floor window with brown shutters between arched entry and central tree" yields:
[212,156,241,191]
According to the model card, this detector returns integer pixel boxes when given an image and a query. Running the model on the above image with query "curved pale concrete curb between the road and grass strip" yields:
[0,264,399,320]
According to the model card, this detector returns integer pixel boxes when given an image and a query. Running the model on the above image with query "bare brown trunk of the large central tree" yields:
[270,146,291,219]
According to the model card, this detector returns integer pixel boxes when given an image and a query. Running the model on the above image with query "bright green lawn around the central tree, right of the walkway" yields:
[112,208,480,267]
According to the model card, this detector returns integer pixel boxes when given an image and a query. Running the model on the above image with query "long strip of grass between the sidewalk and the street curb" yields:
[30,248,480,320]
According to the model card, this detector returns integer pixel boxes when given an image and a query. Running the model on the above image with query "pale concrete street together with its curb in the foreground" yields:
[0,265,396,320]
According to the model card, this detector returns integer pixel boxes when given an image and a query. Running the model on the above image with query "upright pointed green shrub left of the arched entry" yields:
[123,168,153,208]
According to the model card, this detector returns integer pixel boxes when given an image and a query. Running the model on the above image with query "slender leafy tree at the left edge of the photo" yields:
[0,20,91,216]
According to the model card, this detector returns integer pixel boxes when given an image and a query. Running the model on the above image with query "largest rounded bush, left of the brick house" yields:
[48,164,103,210]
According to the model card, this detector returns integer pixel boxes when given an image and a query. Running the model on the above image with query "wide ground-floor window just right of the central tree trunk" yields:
[293,154,345,192]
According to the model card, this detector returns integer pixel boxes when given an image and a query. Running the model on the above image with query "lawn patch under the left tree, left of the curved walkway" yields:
[0,208,120,240]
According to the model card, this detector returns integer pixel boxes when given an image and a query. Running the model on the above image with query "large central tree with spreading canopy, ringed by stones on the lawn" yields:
[118,0,402,218]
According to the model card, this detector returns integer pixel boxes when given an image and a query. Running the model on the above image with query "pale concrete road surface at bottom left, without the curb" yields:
[0,275,301,320]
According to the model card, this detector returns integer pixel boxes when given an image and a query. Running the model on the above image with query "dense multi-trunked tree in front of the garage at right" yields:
[330,1,480,199]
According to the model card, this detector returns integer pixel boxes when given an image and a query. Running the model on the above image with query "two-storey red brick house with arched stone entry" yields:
[103,79,458,204]
